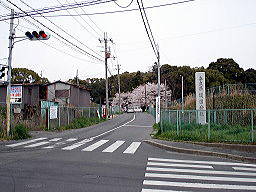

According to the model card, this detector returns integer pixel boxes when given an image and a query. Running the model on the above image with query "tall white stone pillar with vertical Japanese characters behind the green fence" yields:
[195,72,206,125]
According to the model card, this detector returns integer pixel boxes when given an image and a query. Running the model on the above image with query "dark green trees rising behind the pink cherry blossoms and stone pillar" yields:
[70,58,256,104]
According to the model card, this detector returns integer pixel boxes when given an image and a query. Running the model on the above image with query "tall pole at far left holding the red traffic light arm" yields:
[6,9,14,136]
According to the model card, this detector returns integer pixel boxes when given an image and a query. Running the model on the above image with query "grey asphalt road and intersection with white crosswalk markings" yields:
[0,113,256,192]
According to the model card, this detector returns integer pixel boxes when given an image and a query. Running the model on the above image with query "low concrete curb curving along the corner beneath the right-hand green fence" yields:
[143,140,256,163]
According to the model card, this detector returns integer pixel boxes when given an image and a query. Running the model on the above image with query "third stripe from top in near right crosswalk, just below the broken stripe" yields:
[146,167,256,176]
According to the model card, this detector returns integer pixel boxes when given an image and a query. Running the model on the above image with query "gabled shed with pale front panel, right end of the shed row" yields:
[45,81,91,107]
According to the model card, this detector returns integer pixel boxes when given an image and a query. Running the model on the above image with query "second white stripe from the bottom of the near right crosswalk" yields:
[143,180,256,191]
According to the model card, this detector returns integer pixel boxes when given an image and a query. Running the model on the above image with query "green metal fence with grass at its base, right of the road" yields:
[155,109,256,143]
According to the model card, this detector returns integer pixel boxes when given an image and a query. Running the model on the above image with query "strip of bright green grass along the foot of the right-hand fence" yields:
[155,123,255,143]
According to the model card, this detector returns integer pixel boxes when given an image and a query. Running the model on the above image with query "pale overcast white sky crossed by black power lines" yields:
[0,0,256,81]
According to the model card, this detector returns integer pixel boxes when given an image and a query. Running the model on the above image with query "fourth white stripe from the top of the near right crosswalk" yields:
[145,173,256,183]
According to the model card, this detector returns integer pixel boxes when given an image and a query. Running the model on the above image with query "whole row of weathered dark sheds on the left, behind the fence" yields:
[0,81,91,109]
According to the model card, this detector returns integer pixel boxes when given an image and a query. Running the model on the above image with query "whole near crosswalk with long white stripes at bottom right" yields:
[141,157,256,192]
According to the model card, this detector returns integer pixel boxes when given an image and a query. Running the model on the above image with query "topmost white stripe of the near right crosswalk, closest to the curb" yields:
[148,158,256,167]
